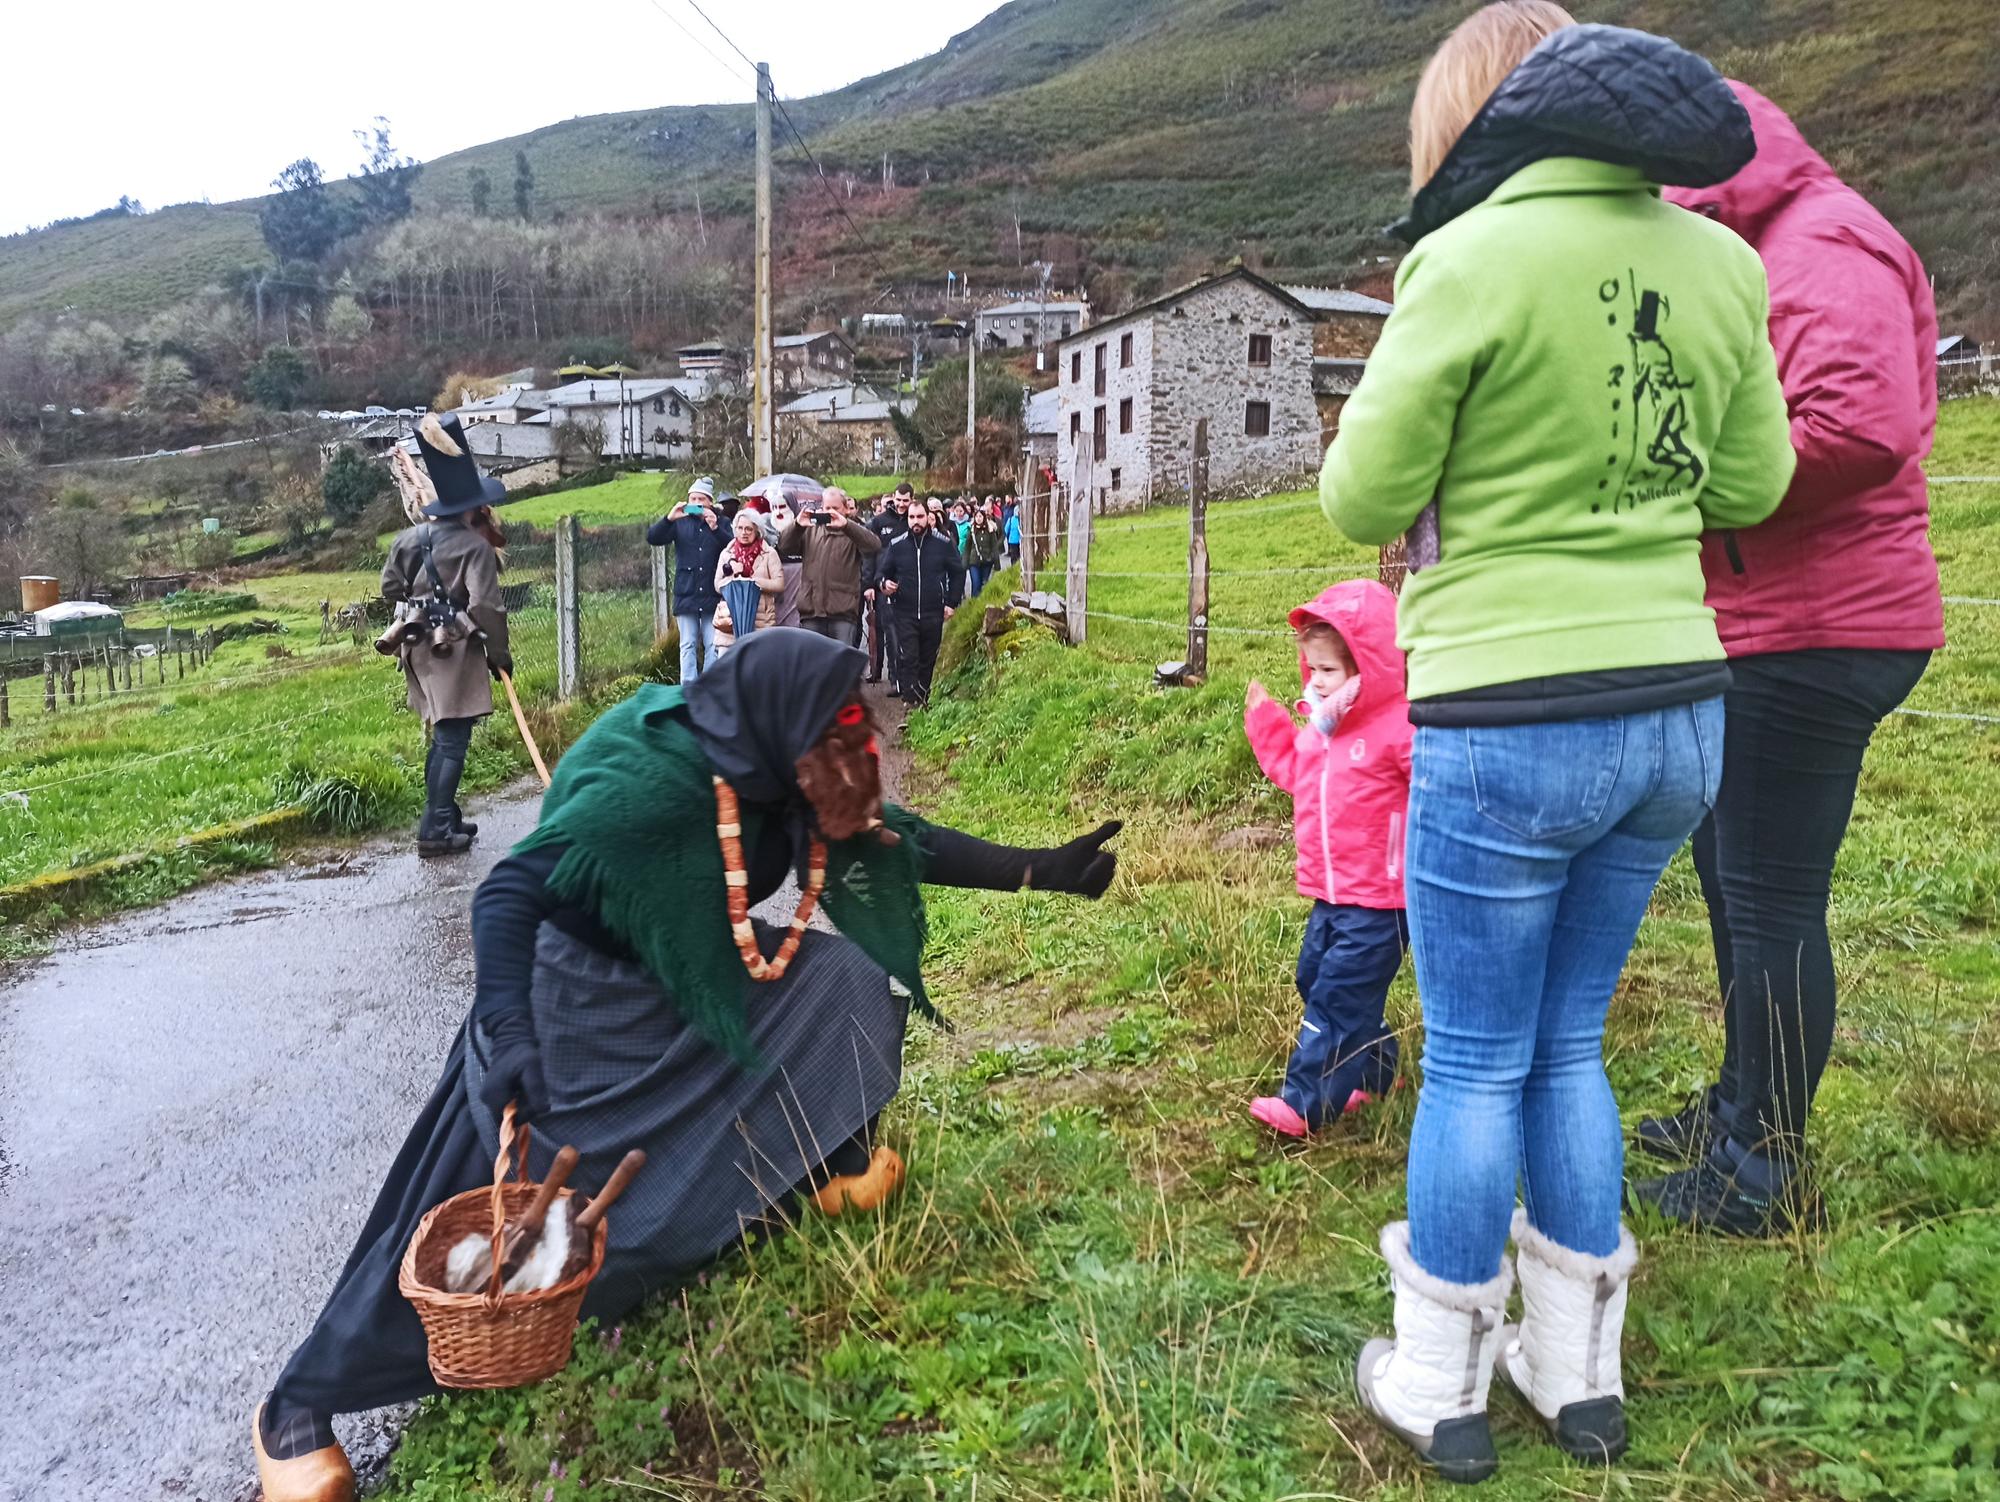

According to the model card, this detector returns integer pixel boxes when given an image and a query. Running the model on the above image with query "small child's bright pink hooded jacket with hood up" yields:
[1244,580,1412,908]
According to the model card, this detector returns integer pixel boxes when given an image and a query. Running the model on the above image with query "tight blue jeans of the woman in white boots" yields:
[1404,698,1722,1284]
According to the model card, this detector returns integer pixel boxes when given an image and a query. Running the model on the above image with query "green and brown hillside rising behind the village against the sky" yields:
[0,0,2000,334]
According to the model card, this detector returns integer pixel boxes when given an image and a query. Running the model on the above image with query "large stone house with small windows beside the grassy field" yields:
[1056,266,1320,510]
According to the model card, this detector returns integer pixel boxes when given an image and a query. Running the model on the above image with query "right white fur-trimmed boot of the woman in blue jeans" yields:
[1500,1210,1638,1466]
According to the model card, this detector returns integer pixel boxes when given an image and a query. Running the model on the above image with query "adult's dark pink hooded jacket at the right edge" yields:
[1666,80,1944,658]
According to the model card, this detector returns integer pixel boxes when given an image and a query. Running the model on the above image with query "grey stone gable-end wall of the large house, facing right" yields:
[1132,278,1320,504]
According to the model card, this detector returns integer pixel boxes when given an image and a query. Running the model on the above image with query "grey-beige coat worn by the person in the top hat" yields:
[382,518,512,724]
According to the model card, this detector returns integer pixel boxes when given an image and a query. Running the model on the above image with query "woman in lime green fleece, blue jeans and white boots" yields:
[1320,0,1792,1480]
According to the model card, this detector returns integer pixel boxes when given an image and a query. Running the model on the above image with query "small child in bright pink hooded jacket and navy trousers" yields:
[1244,580,1410,1138]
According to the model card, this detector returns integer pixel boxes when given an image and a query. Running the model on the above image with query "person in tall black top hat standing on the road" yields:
[382,412,514,858]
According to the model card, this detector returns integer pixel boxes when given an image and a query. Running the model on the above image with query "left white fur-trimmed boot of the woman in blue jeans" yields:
[1354,1220,1514,1482]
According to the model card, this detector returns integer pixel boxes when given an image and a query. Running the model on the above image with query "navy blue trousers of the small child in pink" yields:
[1280,902,1410,1132]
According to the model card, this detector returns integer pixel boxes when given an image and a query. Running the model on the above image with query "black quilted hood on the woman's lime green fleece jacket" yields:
[1390,26,1756,244]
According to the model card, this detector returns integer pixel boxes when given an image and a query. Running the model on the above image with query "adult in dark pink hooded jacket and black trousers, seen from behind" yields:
[1634,82,1944,1236]
